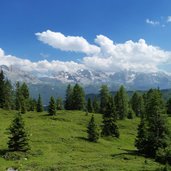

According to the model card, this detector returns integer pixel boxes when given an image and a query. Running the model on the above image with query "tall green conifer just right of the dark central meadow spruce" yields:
[114,86,128,119]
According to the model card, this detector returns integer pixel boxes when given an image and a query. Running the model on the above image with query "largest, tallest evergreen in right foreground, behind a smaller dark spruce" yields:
[137,89,170,157]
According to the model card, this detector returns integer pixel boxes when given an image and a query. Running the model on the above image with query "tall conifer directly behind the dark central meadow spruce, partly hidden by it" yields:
[100,85,109,114]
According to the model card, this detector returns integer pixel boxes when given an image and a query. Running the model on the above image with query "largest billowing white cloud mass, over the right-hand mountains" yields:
[83,35,171,72]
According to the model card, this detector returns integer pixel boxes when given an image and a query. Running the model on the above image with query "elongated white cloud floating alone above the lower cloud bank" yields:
[35,30,100,54]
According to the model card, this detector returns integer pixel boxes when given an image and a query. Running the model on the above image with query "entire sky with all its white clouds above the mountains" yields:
[0,0,171,74]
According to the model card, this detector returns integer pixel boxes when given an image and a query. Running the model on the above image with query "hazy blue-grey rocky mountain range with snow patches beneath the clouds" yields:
[0,65,171,103]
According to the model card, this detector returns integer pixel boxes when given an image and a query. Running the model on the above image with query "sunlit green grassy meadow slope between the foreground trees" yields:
[0,110,164,171]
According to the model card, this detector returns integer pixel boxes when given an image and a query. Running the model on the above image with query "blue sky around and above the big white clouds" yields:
[0,0,171,71]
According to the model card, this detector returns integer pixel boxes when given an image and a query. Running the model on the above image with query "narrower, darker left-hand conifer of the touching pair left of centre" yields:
[65,84,73,110]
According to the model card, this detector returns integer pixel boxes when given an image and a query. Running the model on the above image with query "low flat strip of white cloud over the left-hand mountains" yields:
[0,48,84,76]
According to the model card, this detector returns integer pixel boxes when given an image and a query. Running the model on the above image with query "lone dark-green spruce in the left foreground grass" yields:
[8,113,30,152]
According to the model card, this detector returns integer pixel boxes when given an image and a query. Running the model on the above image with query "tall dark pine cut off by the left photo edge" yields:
[0,70,5,108]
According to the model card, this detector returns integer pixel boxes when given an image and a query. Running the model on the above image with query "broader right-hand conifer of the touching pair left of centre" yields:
[72,84,85,110]
